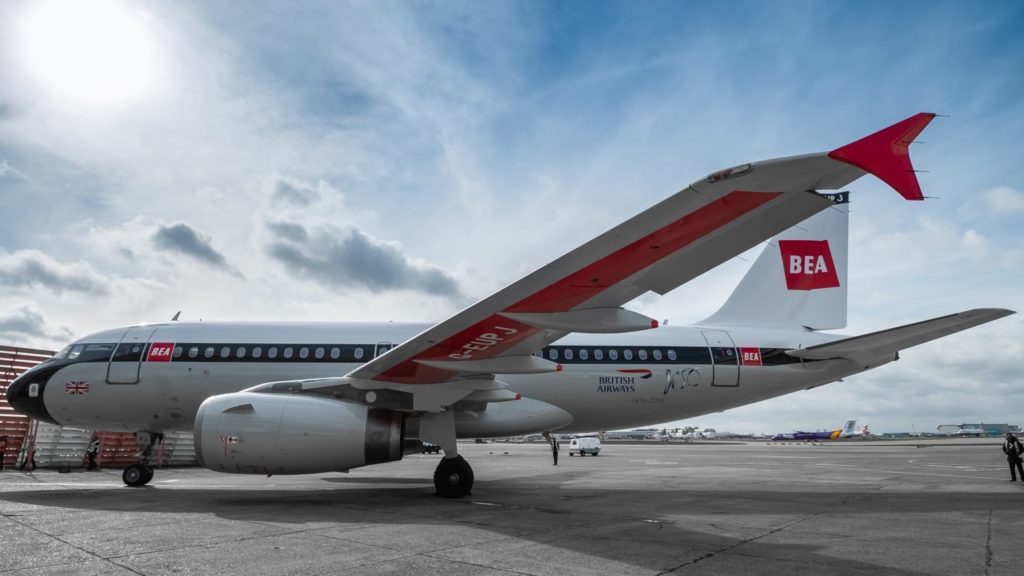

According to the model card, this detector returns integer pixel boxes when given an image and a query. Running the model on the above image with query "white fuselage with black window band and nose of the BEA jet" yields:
[8,323,893,437]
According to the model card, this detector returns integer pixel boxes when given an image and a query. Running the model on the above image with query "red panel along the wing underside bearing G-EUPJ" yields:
[374,191,782,384]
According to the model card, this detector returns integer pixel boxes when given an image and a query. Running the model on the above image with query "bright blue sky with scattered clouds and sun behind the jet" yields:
[0,0,1024,433]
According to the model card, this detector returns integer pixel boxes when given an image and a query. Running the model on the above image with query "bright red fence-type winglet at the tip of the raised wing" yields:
[828,112,935,200]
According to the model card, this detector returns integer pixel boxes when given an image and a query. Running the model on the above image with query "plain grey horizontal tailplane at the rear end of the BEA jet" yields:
[785,308,1014,362]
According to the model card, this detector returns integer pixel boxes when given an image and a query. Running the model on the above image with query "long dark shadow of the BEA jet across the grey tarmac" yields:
[0,477,993,576]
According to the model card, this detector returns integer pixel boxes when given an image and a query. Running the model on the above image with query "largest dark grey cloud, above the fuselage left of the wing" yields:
[266,222,462,298]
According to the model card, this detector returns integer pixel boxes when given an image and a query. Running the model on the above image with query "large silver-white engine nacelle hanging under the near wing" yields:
[195,392,404,475]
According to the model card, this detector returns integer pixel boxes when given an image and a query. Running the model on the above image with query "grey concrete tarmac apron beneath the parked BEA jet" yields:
[0,438,1024,576]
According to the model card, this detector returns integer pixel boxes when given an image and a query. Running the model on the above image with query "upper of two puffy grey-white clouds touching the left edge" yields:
[0,249,111,295]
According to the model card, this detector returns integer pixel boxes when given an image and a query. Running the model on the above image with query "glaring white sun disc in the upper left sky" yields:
[20,0,159,105]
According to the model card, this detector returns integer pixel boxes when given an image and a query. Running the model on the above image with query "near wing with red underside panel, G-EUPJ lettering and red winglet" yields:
[347,113,935,388]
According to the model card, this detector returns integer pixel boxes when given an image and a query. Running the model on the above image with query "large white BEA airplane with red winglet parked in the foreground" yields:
[7,113,1014,497]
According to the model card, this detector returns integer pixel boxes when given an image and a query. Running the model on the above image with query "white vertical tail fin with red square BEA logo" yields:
[700,192,850,330]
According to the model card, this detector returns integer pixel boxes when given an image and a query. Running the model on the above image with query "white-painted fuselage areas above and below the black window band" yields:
[36,323,893,436]
